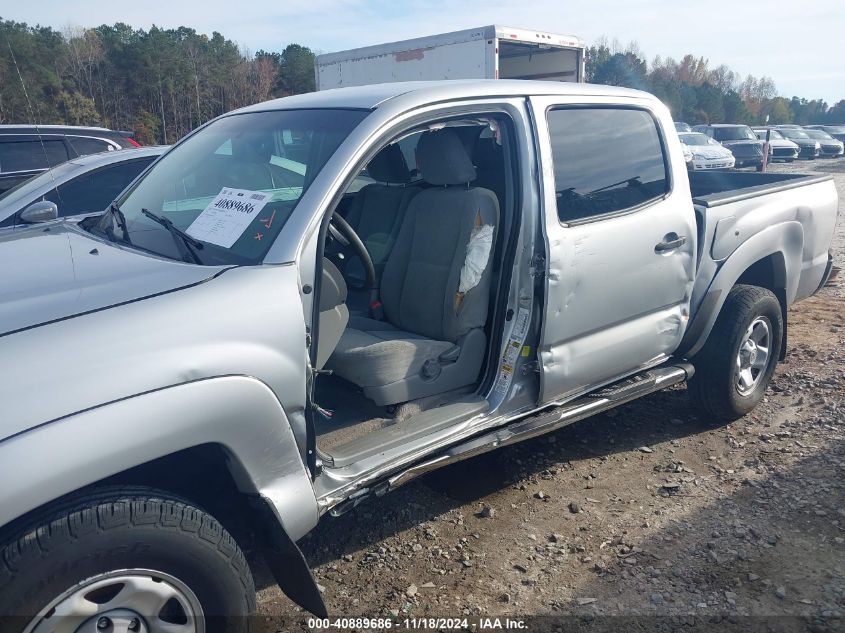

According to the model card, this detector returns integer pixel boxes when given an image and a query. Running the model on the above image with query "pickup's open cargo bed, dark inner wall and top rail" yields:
[689,171,833,208]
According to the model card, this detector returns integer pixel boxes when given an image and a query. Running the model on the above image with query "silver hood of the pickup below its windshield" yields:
[0,221,231,336]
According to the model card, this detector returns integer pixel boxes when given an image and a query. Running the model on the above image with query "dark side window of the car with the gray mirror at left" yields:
[44,157,154,217]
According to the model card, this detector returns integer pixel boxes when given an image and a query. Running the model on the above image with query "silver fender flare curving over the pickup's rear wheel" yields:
[677,221,804,357]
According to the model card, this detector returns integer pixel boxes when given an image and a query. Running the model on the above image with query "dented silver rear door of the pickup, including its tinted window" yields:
[531,96,696,402]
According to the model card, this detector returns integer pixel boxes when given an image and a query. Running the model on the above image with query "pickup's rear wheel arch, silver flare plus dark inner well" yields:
[677,222,804,360]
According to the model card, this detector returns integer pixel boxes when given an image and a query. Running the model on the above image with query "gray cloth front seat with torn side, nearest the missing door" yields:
[327,128,499,405]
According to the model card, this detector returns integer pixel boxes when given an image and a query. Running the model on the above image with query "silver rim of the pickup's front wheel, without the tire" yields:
[24,569,205,633]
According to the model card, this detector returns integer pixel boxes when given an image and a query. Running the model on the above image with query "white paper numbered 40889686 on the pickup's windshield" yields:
[185,188,273,248]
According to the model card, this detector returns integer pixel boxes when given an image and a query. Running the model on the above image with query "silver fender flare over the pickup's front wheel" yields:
[0,376,319,540]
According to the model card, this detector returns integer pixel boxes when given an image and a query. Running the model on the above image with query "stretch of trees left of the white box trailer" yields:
[0,20,314,144]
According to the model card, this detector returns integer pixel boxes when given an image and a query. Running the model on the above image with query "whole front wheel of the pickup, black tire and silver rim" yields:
[0,488,255,633]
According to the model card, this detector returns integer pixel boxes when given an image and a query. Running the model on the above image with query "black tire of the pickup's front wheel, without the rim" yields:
[0,487,255,633]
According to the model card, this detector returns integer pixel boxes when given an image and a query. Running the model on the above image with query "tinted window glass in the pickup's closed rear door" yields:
[548,107,669,222]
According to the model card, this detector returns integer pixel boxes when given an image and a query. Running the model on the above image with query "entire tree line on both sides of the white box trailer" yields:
[0,19,845,144]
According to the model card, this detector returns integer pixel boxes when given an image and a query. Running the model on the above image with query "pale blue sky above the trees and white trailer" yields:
[6,0,845,104]
